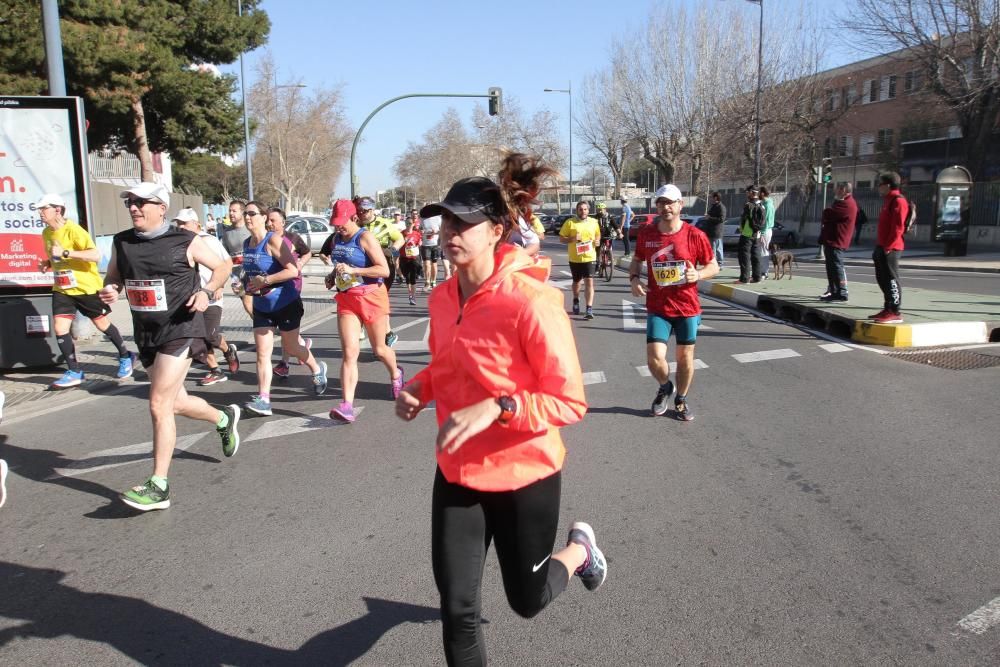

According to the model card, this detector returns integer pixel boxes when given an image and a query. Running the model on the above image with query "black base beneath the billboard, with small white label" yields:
[0,294,62,370]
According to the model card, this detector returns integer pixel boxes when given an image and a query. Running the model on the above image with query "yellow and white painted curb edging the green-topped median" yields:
[618,258,1000,347]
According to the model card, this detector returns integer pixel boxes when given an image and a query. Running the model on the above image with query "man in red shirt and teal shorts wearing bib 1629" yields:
[628,184,719,421]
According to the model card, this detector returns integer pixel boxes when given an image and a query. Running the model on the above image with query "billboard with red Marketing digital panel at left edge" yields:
[0,96,90,295]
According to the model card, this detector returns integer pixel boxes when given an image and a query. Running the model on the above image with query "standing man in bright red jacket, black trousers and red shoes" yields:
[871,171,910,324]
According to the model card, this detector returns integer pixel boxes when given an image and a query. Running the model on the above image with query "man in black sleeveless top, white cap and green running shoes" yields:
[100,183,240,512]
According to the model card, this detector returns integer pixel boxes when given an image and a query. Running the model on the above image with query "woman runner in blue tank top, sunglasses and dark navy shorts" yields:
[243,201,327,415]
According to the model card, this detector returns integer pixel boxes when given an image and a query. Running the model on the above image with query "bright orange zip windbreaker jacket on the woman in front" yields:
[410,244,587,491]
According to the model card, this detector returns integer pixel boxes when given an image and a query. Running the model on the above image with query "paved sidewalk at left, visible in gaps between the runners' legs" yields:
[0,272,335,417]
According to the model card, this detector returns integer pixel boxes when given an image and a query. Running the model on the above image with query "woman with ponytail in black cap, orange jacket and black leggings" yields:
[396,153,607,665]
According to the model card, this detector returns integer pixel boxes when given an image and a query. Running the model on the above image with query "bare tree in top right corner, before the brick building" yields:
[844,0,1000,177]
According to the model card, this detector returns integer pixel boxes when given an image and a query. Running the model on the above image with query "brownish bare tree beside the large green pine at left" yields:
[248,53,353,209]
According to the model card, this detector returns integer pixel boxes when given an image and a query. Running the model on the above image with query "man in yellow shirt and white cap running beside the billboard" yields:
[35,194,135,389]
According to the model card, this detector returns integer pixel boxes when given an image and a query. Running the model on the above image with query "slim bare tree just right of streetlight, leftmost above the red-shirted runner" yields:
[576,70,630,199]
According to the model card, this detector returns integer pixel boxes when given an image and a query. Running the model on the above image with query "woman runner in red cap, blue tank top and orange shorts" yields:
[326,199,403,423]
